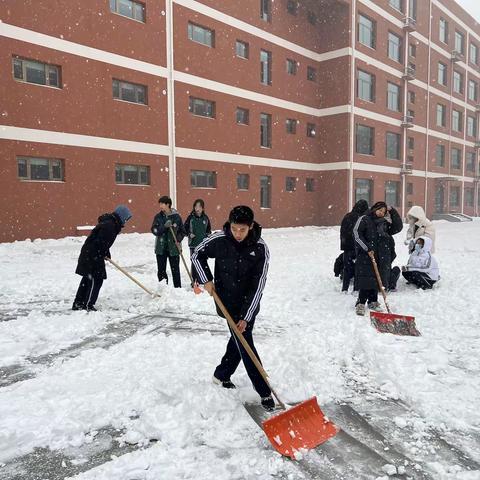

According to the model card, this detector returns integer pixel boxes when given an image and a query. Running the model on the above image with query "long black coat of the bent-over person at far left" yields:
[75,213,123,279]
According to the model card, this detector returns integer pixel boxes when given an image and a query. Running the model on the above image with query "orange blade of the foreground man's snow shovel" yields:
[263,397,338,458]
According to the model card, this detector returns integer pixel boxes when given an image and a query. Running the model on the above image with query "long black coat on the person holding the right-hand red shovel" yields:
[353,208,403,290]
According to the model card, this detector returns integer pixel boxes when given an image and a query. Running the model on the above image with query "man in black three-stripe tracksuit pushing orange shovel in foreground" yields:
[192,205,275,410]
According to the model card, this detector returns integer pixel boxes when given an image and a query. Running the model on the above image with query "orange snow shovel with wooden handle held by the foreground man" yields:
[212,289,338,459]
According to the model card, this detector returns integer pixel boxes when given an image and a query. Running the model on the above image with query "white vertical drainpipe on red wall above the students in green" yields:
[165,0,177,206]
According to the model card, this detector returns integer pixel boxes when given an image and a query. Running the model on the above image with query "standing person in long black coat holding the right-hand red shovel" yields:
[353,202,403,315]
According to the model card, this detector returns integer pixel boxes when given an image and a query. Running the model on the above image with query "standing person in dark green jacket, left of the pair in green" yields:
[151,196,185,288]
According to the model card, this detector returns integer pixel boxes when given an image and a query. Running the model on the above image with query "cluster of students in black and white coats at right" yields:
[334,200,440,315]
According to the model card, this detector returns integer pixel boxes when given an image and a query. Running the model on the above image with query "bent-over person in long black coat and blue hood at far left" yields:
[72,205,132,311]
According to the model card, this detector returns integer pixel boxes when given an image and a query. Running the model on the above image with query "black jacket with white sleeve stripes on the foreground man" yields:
[192,222,270,322]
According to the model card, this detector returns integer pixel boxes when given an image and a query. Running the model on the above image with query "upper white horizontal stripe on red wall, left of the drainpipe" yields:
[0,22,167,77]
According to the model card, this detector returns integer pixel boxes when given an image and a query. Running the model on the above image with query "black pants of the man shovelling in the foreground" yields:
[214,319,272,397]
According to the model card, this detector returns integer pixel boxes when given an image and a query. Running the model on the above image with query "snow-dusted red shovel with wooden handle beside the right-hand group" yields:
[369,253,420,337]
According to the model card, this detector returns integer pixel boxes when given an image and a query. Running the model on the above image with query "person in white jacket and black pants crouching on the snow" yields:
[402,236,440,290]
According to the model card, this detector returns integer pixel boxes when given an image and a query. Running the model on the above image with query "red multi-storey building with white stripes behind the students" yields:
[0,0,480,242]
